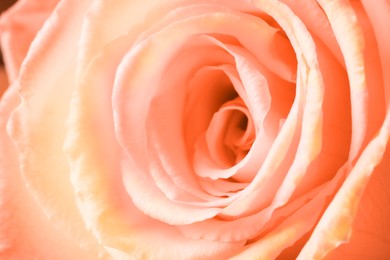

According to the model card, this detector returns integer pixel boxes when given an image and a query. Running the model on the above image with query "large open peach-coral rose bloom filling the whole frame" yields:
[2,1,389,258]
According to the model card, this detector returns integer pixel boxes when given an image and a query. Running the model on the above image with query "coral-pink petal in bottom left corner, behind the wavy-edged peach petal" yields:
[0,88,96,260]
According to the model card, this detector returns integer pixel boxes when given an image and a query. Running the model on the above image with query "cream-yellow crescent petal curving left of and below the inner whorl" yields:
[66,25,243,259]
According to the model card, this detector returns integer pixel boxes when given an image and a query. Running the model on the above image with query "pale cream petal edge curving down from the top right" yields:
[317,0,368,161]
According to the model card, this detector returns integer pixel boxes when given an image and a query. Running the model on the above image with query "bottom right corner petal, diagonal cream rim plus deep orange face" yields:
[299,110,390,259]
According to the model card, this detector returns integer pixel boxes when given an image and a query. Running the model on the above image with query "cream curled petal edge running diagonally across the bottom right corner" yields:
[298,111,390,259]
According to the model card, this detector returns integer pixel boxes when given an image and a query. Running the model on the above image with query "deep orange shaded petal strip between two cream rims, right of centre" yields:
[292,32,352,201]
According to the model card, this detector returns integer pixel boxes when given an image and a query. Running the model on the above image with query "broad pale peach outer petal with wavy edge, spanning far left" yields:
[9,0,106,254]
